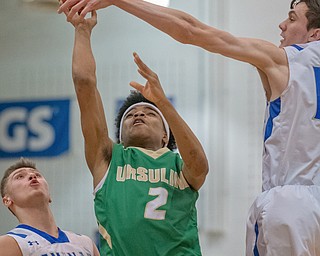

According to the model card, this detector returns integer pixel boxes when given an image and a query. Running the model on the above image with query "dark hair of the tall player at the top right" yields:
[290,0,320,30]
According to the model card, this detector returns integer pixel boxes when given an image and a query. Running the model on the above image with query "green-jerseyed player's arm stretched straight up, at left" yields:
[67,11,113,185]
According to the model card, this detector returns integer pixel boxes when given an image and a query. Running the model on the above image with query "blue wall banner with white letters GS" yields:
[0,99,70,158]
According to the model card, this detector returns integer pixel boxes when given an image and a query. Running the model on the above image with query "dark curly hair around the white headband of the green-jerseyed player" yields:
[115,91,177,150]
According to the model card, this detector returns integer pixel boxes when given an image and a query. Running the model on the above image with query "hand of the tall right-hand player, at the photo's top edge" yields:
[58,0,113,21]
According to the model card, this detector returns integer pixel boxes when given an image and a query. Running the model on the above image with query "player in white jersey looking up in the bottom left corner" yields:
[0,158,100,256]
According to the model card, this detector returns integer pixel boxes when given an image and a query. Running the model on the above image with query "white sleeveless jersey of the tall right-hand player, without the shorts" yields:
[262,41,320,190]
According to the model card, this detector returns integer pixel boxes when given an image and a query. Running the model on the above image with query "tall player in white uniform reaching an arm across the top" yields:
[58,0,320,256]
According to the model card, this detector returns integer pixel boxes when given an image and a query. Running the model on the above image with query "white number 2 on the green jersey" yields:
[144,187,168,220]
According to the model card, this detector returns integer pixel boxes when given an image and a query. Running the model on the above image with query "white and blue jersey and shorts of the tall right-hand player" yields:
[247,41,320,256]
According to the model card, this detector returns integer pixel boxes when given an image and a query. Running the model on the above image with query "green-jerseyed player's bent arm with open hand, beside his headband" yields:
[130,53,209,190]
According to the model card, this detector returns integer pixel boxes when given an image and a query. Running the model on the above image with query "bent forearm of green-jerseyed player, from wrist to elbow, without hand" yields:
[157,99,208,189]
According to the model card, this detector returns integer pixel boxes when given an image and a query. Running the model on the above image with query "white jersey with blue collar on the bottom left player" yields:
[7,224,94,256]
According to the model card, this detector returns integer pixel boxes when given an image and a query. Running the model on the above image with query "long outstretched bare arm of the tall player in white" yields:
[60,0,288,99]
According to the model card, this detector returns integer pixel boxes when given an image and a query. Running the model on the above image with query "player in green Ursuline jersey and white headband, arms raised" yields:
[65,12,208,256]
